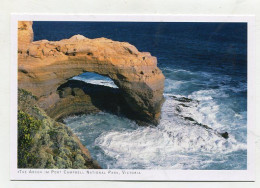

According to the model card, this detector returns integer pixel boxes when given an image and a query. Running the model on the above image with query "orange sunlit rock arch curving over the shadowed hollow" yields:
[18,22,164,124]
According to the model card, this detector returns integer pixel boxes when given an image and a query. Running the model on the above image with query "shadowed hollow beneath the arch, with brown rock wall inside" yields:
[47,72,146,125]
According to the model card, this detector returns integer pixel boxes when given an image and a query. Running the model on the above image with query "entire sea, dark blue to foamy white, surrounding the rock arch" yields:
[33,22,247,170]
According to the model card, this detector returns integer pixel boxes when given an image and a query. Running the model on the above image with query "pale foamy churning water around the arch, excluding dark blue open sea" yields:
[65,69,247,169]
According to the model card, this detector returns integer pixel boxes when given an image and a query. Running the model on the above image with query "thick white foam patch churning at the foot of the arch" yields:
[95,97,246,169]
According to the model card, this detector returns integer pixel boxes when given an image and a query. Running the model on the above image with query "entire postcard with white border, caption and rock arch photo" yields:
[11,15,255,181]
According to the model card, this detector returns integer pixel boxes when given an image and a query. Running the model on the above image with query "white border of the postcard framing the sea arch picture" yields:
[10,14,255,181]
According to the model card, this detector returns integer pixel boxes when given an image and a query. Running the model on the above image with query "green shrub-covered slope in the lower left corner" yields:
[18,89,100,169]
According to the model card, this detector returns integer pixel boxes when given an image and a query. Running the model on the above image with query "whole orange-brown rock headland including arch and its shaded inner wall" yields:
[18,21,164,168]
